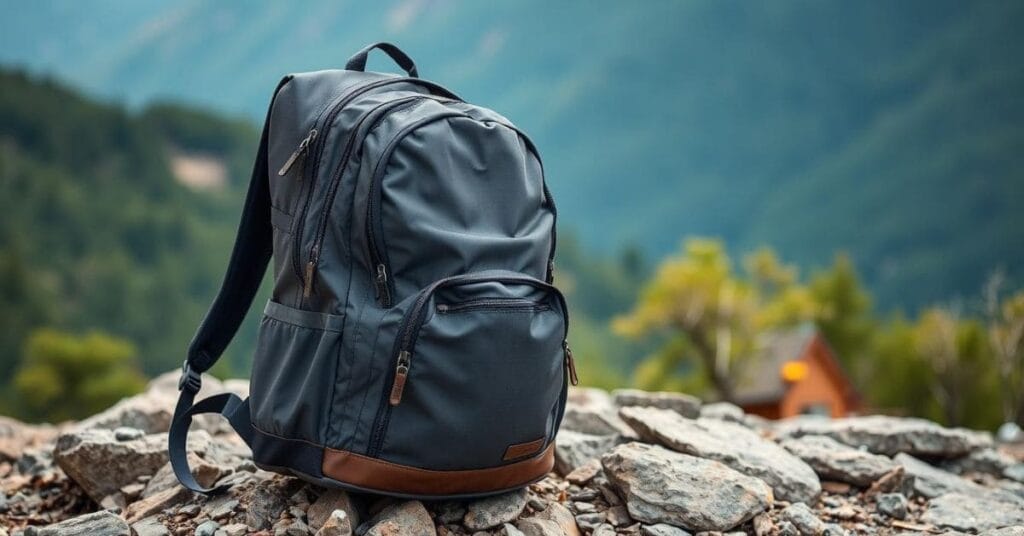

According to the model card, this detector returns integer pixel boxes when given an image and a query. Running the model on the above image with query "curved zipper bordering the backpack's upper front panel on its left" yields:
[366,111,472,307]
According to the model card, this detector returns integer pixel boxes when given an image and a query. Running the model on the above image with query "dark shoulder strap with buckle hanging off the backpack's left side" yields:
[167,77,291,493]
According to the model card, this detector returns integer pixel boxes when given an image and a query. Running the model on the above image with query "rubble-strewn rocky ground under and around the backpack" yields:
[0,373,1024,536]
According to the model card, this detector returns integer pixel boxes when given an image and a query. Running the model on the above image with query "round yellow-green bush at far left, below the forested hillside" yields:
[13,328,145,421]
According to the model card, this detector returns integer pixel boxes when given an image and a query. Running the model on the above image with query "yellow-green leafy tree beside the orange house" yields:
[612,239,816,400]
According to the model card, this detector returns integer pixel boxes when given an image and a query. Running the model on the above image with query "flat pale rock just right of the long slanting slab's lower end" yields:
[781,436,898,488]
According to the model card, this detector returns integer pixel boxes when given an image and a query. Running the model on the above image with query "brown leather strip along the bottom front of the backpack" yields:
[323,443,555,496]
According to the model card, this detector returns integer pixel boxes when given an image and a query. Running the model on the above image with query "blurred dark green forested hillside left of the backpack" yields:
[0,71,256,381]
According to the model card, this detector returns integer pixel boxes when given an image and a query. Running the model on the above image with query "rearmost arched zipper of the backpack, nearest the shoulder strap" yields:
[290,77,460,295]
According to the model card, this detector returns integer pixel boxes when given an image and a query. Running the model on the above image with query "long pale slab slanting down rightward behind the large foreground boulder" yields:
[620,408,821,502]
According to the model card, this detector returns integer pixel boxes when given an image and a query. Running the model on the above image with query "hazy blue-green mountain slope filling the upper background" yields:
[0,0,1024,308]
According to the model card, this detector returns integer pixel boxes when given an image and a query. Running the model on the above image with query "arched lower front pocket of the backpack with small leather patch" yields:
[368,272,567,470]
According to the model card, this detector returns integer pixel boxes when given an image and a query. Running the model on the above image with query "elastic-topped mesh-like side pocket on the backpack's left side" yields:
[250,301,344,445]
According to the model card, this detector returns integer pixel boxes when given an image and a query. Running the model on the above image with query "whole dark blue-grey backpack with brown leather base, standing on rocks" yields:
[168,43,577,498]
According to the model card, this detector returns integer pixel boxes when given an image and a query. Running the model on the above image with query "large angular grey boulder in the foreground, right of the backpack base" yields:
[601,442,773,531]
